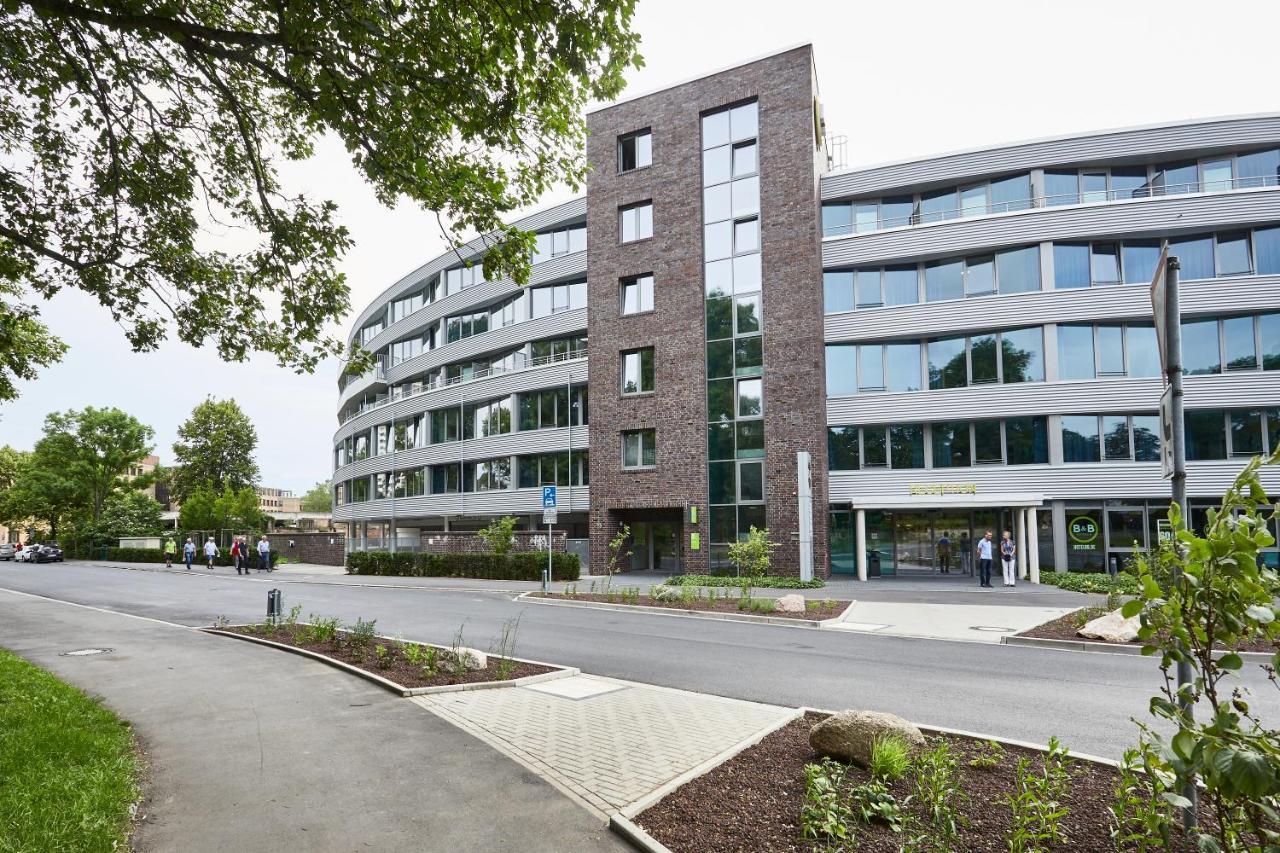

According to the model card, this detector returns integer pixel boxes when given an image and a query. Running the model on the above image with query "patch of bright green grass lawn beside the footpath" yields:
[0,648,138,853]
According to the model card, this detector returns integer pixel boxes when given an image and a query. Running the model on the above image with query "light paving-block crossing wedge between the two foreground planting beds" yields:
[412,676,796,816]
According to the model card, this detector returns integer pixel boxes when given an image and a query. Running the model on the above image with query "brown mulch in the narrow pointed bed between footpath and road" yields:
[220,625,552,688]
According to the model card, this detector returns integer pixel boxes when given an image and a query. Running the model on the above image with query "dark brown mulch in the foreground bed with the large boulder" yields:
[645,715,1203,853]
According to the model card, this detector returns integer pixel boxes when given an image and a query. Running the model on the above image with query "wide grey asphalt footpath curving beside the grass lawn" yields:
[0,590,627,853]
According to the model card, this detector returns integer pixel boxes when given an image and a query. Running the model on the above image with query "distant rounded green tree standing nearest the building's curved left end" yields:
[172,397,257,502]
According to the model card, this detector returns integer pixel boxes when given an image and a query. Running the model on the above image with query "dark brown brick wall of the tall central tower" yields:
[588,46,827,574]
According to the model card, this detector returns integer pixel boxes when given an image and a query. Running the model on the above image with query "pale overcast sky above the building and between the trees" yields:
[0,0,1280,494]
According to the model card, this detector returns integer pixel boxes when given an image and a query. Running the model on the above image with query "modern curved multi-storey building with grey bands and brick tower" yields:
[334,46,1280,576]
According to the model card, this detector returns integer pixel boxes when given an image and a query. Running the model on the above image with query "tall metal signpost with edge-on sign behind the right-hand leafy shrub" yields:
[1151,246,1197,829]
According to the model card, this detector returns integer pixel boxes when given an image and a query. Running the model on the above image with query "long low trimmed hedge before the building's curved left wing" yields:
[347,551,581,580]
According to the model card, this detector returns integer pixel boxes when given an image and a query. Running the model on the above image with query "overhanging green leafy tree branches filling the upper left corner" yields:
[0,0,639,391]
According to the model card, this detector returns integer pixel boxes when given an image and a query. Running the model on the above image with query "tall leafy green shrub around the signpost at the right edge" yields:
[1121,452,1280,850]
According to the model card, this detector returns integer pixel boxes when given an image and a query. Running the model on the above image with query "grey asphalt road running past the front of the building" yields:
[0,562,1280,757]
